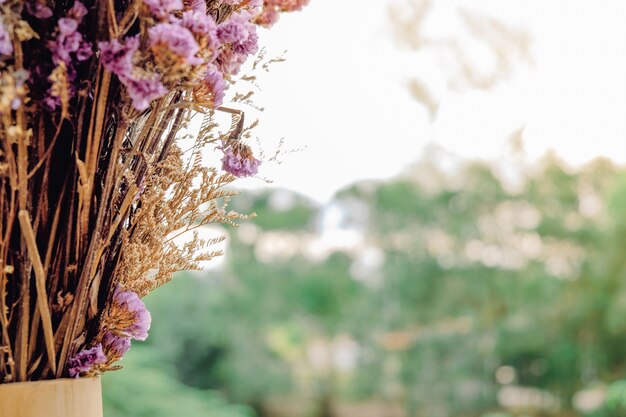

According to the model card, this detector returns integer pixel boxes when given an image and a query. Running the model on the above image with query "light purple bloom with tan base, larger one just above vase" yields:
[107,285,152,340]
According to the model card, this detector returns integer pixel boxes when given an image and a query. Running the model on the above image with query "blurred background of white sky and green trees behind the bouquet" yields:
[103,0,626,417]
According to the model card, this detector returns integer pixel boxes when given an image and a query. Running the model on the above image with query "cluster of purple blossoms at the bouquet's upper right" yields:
[98,0,263,110]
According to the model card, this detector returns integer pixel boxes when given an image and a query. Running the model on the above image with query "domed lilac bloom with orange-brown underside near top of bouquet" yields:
[148,23,202,65]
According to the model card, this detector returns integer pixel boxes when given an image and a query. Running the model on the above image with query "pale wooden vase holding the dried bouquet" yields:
[0,377,102,417]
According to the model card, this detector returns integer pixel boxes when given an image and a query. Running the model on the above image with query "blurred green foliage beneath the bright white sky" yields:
[105,157,626,417]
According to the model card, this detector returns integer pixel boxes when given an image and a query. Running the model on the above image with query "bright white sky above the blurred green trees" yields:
[232,0,626,201]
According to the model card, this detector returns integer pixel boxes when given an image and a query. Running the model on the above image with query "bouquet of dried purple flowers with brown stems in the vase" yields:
[0,0,307,383]
